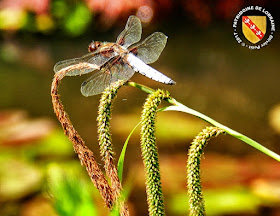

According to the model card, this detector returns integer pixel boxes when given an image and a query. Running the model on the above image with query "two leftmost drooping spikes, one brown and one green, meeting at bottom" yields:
[51,64,129,216]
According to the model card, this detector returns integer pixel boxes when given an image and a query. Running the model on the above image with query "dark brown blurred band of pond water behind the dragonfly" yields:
[0,25,280,155]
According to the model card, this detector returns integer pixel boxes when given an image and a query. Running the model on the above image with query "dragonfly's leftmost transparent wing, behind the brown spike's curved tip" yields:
[53,53,114,76]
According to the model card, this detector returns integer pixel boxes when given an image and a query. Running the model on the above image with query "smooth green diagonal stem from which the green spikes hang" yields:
[127,82,280,162]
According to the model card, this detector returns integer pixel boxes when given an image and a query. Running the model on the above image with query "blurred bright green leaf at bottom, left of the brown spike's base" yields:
[47,163,98,216]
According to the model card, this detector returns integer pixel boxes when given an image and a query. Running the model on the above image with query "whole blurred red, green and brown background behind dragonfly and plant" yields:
[0,0,280,216]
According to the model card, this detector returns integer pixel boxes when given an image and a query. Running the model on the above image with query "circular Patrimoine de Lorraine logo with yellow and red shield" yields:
[232,6,275,50]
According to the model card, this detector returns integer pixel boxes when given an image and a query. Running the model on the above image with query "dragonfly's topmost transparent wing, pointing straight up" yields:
[117,16,142,48]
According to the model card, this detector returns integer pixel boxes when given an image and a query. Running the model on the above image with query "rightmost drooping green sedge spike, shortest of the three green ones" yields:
[187,127,225,216]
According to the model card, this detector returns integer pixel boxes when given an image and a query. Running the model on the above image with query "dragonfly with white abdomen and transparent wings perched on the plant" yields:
[54,16,176,97]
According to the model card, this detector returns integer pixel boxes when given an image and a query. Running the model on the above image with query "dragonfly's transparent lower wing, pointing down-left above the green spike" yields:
[81,60,134,97]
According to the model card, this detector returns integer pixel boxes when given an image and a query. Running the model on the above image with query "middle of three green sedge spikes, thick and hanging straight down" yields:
[141,90,169,216]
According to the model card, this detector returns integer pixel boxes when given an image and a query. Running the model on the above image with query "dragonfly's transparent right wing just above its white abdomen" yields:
[129,32,167,64]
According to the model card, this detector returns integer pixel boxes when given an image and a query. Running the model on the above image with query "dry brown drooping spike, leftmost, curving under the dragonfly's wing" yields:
[51,63,115,209]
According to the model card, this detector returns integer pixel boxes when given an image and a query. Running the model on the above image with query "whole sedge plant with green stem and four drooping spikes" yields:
[51,63,280,216]
